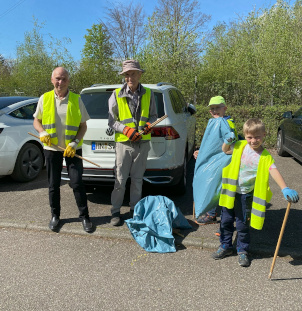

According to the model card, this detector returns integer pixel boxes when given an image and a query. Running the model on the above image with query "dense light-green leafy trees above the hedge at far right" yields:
[199,0,302,105]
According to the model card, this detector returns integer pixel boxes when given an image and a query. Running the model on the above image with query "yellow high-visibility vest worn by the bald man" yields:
[42,91,83,146]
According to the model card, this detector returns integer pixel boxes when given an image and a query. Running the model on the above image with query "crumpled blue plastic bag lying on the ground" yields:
[126,196,192,253]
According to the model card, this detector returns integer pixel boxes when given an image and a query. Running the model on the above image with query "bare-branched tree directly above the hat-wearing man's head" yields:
[101,2,146,59]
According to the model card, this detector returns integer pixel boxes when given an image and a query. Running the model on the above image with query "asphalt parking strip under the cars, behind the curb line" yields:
[0,154,302,258]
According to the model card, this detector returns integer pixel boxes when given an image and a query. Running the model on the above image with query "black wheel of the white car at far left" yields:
[11,143,43,182]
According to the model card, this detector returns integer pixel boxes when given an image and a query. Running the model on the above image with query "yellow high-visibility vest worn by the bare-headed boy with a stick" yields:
[219,140,274,230]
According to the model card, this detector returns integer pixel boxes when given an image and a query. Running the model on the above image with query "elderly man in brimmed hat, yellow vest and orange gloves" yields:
[108,60,157,226]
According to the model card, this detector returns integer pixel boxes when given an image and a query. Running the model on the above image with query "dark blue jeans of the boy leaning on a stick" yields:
[220,192,253,254]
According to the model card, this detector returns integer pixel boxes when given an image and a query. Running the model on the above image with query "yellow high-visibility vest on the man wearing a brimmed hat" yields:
[115,87,151,142]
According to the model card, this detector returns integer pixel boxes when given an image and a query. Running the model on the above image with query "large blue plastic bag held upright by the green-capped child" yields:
[193,118,231,218]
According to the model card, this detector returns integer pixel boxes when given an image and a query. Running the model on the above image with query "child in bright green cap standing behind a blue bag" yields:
[194,96,238,230]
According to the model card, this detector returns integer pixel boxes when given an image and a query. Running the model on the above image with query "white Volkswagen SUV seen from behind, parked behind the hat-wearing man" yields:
[62,83,196,193]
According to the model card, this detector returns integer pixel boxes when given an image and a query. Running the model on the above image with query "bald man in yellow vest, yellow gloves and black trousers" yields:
[34,67,93,232]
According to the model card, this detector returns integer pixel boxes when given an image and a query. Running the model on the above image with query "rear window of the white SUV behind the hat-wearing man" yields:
[81,91,165,119]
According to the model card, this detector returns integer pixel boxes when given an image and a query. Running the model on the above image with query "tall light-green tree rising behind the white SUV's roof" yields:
[140,0,210,99]
